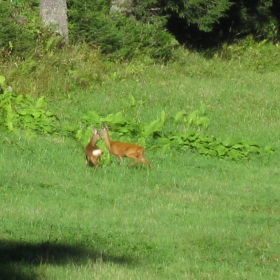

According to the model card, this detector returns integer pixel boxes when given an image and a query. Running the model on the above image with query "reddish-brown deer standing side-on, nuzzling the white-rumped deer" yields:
[98,125,151,168]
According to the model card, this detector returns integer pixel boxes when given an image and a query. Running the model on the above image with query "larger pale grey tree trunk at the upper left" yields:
[40,0,68,41]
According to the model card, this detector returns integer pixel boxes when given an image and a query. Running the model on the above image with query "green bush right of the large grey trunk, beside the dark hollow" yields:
[68,0,178,59]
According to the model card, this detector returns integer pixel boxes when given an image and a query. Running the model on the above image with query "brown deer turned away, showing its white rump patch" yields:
[85,128,102,168]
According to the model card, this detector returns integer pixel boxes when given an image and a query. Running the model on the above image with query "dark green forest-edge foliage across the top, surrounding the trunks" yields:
[0,0,280,61]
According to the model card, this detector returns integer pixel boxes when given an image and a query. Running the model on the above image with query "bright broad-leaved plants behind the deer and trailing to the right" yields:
[73,105,274,160]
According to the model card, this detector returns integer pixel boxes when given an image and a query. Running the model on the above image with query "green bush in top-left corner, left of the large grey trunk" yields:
[0,1,65,59]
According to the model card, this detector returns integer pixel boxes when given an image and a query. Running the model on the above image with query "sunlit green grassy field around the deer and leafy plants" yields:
[0,47,280,280]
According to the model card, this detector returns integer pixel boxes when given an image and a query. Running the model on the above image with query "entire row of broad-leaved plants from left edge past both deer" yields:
[0,76,274,160]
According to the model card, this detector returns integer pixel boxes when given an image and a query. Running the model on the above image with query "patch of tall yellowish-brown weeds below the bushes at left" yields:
[0,44,108,96]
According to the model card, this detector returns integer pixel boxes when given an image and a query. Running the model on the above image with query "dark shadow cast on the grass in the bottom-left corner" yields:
[0,240,132,280]
